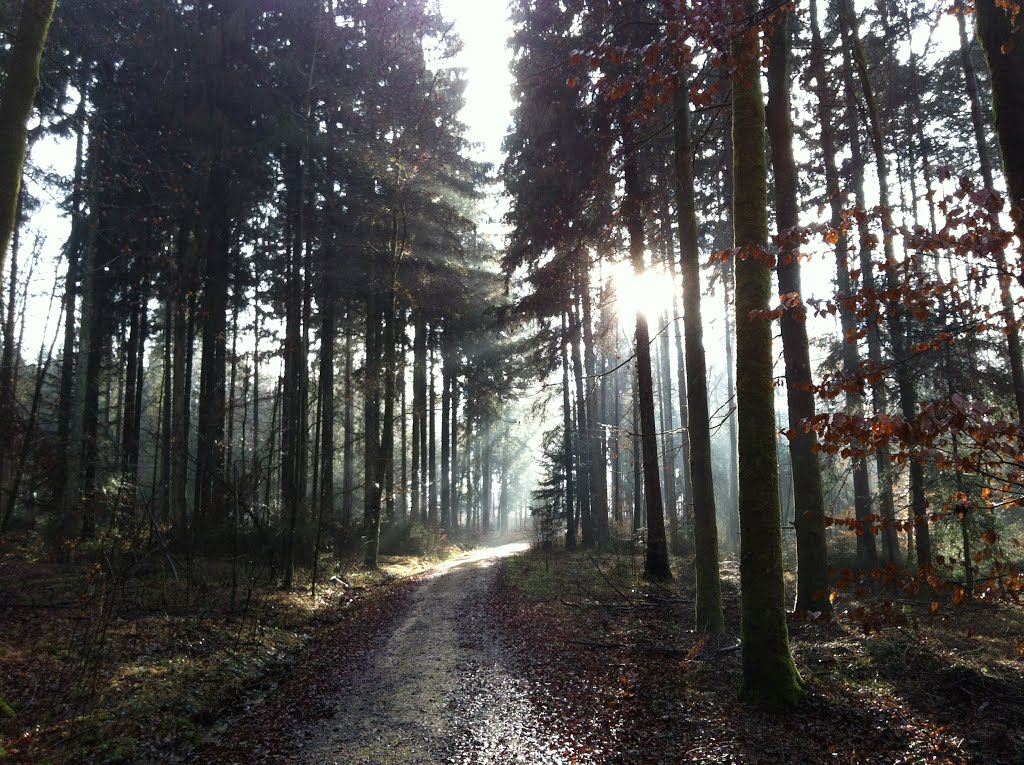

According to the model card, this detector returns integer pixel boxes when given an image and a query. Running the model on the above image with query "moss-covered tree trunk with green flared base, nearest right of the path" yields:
[732,0,803,708]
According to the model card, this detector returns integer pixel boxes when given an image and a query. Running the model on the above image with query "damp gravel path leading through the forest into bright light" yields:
[291,544,573,765]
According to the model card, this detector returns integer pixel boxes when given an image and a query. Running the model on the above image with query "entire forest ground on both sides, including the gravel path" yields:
[0,546,1024,765]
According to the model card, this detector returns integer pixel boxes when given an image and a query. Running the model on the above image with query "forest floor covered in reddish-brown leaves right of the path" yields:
[490,551,1024,765]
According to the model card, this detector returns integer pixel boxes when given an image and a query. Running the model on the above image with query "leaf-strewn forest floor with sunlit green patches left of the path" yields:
[0,536,462,763]
